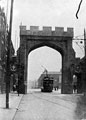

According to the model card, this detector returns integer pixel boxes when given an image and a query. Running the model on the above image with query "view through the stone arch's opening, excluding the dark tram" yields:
[27,46,62,93]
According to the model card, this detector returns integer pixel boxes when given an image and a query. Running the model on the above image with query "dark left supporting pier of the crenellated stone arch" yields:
[18,46,28,94]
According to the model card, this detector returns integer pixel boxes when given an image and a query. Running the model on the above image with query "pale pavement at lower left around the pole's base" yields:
[0,93,23,120]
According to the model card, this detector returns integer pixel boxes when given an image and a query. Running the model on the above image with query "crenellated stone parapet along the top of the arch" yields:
[20,26,74,37]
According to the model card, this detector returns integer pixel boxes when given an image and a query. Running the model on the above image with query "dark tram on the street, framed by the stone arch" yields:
[41,76,53,92]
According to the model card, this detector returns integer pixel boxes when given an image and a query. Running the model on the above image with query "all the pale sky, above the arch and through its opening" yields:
[0,0,86,80]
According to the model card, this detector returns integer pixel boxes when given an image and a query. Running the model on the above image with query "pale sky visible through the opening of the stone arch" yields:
[28,47,62,80]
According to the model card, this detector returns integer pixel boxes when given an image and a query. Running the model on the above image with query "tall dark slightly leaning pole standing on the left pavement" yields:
[6,0,14,108]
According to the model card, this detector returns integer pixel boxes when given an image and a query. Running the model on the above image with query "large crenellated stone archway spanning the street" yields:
[18,26,75,94]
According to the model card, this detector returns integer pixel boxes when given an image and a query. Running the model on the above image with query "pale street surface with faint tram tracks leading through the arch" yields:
[13,90,86,120]
